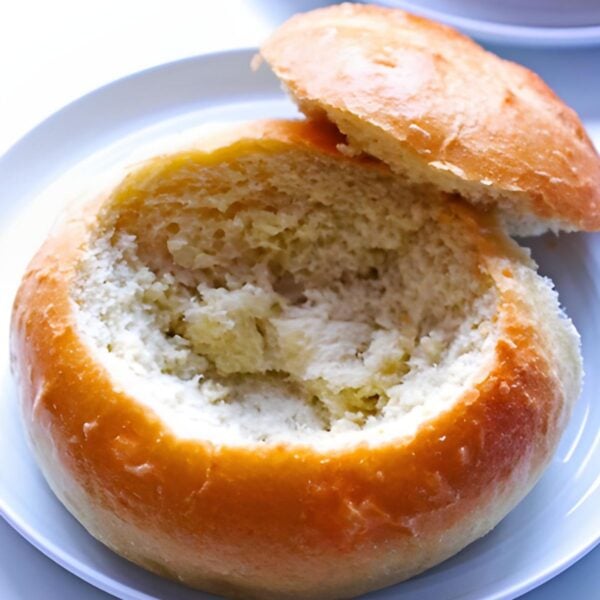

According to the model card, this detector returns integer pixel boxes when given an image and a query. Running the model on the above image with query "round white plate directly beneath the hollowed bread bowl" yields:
[0,50,600,600]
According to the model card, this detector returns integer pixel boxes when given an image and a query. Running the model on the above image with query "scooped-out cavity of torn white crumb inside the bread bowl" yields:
[72,151,497,446]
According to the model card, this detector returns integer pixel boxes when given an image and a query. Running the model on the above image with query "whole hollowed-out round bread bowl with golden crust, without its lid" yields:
[12,122,581,599]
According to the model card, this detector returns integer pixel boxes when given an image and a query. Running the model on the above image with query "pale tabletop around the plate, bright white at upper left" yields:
[0,0,600,600]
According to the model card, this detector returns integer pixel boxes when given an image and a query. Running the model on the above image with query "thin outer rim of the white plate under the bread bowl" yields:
[0,45,600,600]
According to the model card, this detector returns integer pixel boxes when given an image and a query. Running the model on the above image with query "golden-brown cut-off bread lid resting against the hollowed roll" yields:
[261,4,600,235]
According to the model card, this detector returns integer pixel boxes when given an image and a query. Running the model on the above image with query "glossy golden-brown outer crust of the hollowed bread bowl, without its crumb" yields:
[11,123,581,599]
